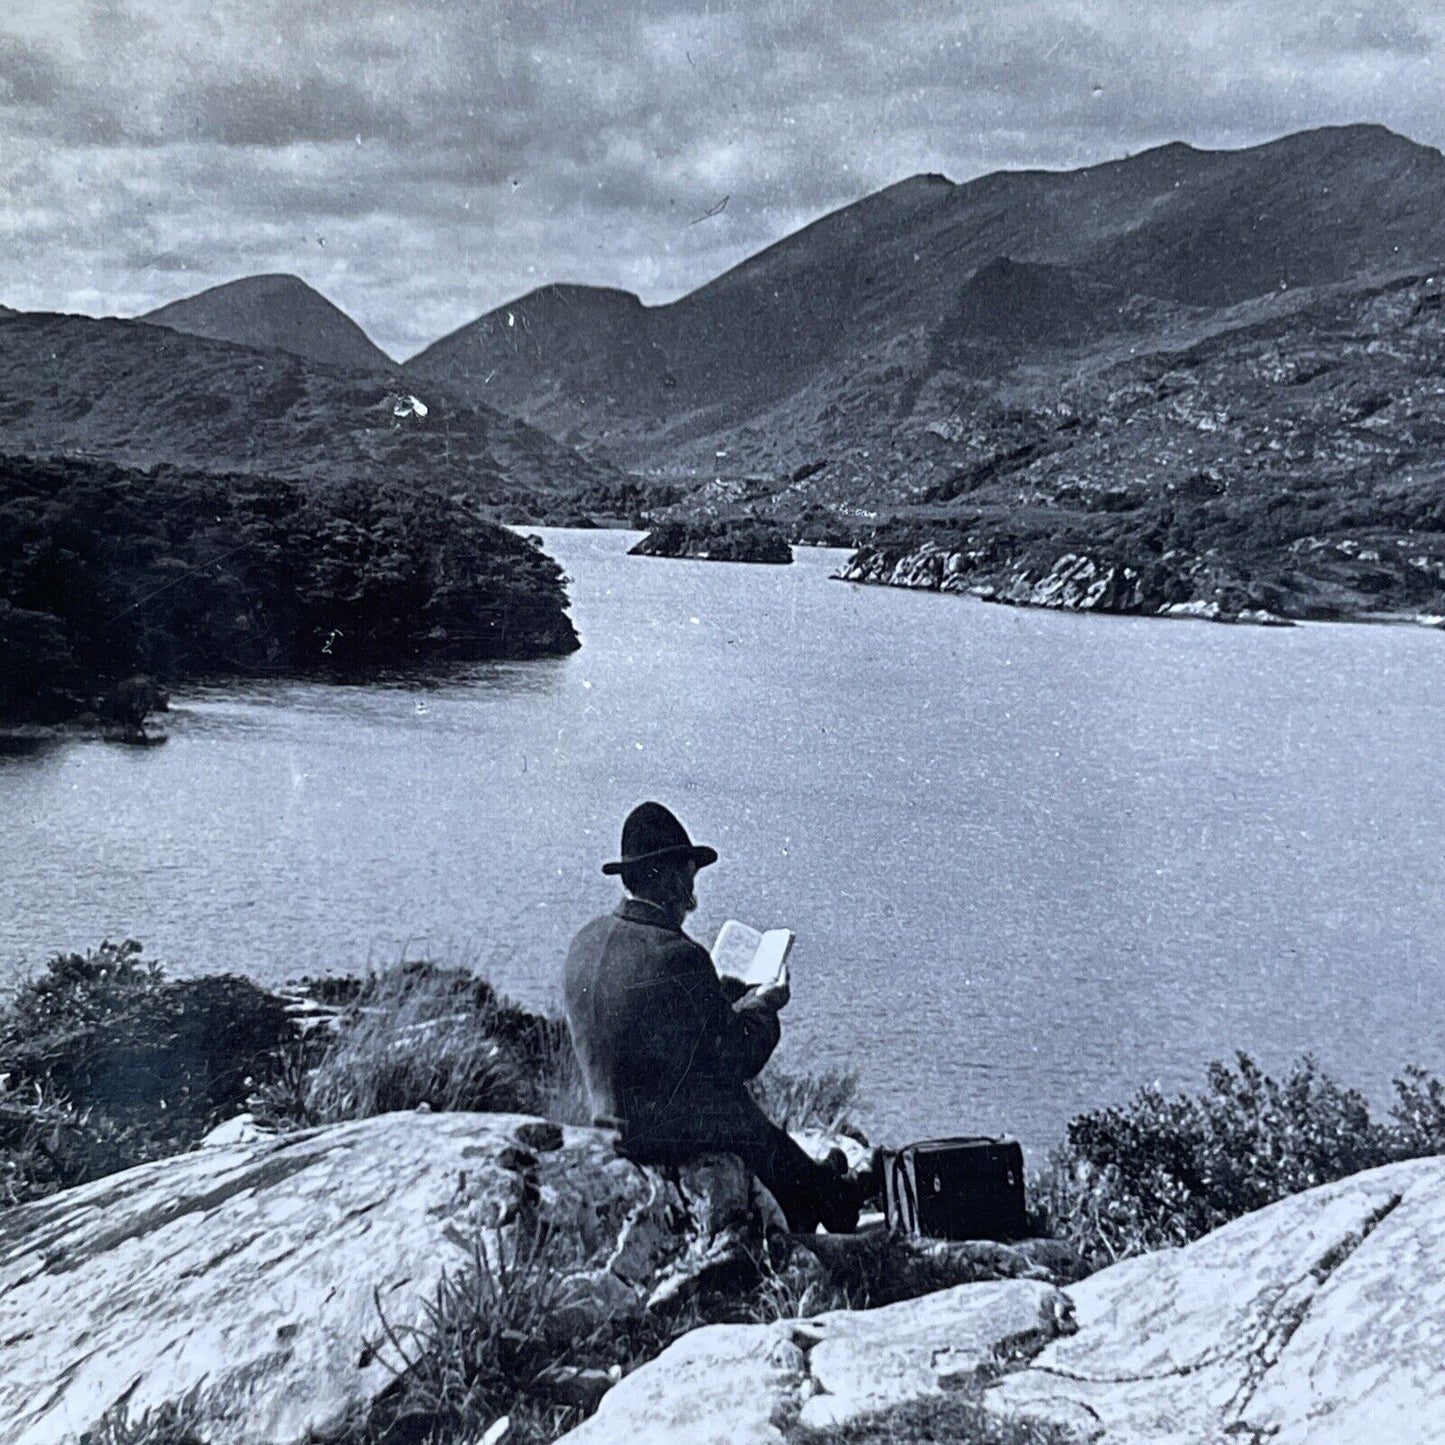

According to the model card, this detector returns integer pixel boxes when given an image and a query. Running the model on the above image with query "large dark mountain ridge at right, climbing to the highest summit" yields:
[406,126,1445,473]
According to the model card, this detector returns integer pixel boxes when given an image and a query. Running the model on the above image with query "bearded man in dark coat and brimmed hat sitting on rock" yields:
[565,802,876,1234]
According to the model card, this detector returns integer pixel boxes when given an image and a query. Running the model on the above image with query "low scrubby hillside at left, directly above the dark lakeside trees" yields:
[0,312,620,517]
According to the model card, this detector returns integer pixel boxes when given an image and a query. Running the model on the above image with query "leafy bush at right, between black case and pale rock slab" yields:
[1036,1053,1445,1267]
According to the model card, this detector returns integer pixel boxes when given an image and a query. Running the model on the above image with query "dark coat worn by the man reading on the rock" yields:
[565,899,780,1152]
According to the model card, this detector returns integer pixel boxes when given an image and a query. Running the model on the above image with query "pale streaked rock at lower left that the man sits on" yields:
[0,1114,756,1445]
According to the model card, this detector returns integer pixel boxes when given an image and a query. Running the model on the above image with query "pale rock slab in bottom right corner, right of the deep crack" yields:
[985,1159,1445,1445]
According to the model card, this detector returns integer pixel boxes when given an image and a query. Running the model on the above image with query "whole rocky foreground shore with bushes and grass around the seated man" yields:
[8,942,1445,1445]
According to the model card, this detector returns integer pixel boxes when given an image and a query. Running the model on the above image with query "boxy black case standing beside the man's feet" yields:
[883,1136,1029,1240]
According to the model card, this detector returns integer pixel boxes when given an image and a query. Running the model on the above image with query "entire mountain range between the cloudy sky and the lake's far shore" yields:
[0,126,1445,598]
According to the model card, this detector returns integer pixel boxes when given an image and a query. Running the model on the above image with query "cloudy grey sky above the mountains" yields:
[0,0,1445,355]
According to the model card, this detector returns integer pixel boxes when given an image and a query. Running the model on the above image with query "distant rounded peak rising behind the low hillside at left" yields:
[137,275,396,371]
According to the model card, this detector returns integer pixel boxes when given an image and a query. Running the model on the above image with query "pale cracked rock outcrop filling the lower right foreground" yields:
[566,1159,1445,1445]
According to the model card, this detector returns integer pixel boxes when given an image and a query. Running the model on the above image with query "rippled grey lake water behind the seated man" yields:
[0,530,1445,1150]
